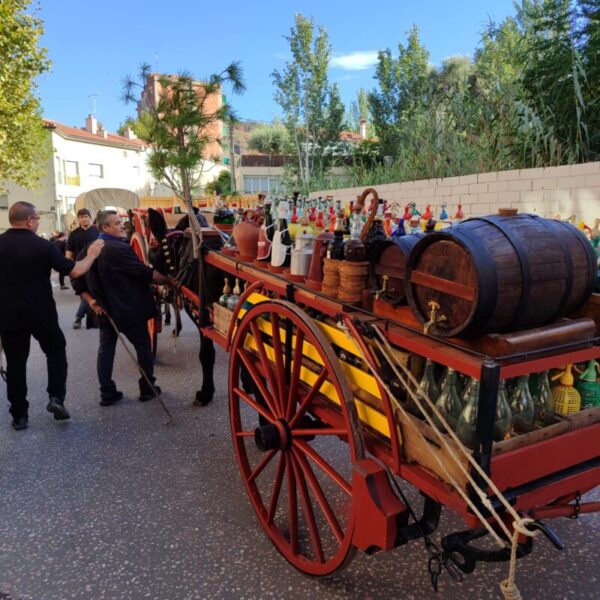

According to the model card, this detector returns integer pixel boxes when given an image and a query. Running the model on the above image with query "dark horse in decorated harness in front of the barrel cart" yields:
[148,208,224,406]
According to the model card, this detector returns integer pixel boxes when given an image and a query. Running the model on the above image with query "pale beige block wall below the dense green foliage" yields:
[311,162,600,226]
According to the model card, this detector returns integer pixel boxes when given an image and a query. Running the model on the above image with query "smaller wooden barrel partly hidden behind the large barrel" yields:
[373,233,424,305]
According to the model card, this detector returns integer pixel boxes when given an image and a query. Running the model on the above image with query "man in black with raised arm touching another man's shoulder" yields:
[0,202,104,431]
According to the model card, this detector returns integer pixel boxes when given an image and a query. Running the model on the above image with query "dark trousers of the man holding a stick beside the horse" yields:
[96,319,155,398]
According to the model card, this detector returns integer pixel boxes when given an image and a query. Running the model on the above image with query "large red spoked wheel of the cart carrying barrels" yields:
[229,300,364,576]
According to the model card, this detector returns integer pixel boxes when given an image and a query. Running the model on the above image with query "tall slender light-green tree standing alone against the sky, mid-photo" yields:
[271,15,344,193]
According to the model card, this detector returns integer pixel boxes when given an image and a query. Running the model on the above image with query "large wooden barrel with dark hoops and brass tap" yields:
[406,214,596,337]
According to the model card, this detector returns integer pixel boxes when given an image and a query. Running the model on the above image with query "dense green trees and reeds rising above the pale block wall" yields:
[350,0,600,185]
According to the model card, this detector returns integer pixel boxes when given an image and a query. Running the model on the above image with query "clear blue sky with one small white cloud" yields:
[39,0,515,131]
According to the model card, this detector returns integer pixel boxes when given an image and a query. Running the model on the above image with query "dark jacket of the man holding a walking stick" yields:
[73,236,158,331]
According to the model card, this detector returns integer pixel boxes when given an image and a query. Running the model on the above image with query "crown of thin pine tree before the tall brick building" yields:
[122,62,245,211]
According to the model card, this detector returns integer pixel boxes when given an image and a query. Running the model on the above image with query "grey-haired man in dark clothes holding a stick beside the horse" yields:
[73,210,171,406]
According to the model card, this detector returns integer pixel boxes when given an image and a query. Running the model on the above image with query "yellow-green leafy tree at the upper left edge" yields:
[0,0,51,188]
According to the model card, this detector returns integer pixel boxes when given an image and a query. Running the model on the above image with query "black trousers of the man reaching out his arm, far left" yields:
[0,321,67,419]
